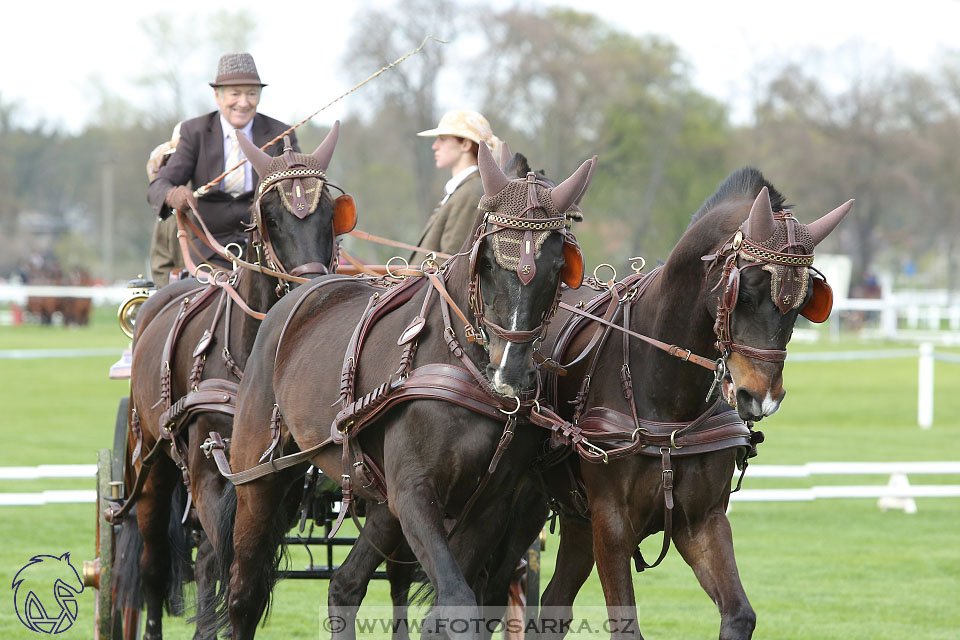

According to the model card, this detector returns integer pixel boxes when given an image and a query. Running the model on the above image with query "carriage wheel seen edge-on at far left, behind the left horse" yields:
[84,398,140,640]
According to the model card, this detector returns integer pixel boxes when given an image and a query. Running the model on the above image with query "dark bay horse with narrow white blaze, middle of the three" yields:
[205,145,592,638]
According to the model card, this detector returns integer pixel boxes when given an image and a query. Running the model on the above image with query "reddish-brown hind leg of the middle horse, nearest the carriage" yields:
[228,475,288,640]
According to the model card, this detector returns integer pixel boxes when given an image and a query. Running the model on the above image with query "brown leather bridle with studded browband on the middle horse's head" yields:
[468,172,582,348]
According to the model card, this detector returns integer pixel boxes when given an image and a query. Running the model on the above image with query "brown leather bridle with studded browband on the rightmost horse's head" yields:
[702,209,813,362]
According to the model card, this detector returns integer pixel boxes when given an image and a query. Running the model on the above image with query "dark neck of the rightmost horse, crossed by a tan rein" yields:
[630,245,718,421]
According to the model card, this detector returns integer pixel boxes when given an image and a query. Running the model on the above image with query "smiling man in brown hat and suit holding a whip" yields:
[147,53,300,267]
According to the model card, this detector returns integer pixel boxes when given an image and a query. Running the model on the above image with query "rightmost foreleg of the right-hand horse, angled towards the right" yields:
[673,509,757,640]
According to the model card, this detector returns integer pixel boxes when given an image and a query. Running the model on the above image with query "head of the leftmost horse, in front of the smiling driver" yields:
[237,121,356,286]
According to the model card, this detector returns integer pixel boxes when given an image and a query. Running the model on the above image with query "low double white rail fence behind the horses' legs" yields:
[0,462,960,513]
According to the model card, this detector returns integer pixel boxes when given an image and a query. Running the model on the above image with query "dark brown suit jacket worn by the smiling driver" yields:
[147,111,300,266]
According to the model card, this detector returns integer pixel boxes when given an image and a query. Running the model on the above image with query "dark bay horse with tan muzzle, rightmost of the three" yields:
[532,168,853,640]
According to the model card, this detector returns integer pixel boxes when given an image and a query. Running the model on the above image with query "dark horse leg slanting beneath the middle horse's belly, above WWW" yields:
[327,503,410,638]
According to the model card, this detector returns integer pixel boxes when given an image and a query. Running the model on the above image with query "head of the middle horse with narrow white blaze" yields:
[470,144,593,396]
